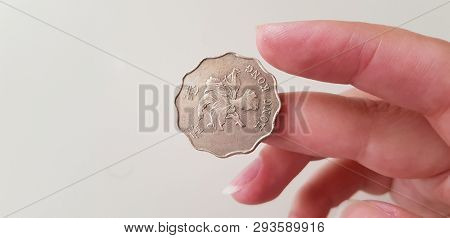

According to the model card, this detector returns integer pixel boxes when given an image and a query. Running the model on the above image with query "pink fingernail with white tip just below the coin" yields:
[222,158,261,195]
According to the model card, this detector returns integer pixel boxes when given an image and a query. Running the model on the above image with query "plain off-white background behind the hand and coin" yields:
[0,0,450,217]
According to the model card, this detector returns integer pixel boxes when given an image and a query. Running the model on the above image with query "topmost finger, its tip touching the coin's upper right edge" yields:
[257,21,450,144]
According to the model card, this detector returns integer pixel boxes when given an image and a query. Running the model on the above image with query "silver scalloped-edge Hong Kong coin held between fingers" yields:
[175,53,280,158]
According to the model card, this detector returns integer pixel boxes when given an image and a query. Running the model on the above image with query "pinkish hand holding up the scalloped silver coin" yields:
[228,21,450,217]
